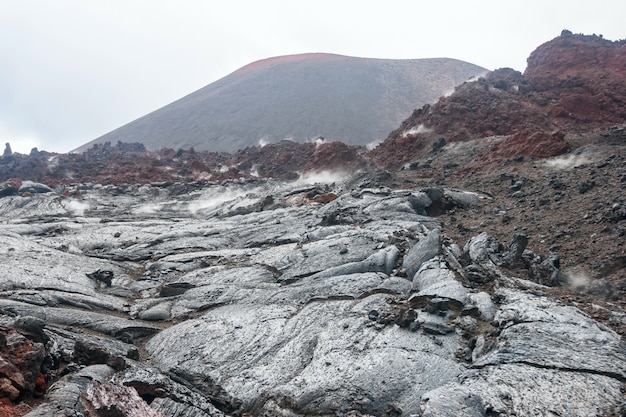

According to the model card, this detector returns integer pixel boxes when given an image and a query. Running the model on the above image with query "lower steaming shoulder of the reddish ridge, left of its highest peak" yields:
[369,69,554,167]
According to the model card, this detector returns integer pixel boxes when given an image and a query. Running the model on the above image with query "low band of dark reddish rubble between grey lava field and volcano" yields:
[0,137,365,184]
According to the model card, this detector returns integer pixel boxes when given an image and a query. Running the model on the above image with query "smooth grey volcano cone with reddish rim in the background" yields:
[76,53,487,152]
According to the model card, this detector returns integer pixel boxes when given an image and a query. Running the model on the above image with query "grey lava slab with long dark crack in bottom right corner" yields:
[421,289,626,417]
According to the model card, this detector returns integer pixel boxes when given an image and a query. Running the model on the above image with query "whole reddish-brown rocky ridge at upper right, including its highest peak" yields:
[369,32,626,167]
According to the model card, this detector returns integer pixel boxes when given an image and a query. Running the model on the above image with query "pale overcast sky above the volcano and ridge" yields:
[0,0,626,153]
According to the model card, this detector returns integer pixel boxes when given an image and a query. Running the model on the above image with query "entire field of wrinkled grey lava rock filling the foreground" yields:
[0,180,626,417]
